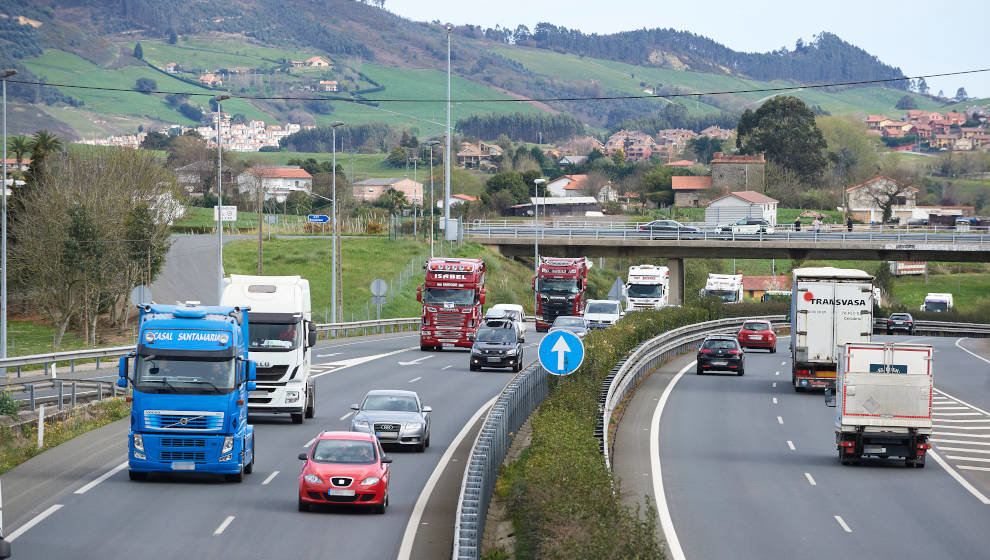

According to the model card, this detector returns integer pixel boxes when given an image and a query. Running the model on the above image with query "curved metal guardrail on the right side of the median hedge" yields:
[595,315,787,469]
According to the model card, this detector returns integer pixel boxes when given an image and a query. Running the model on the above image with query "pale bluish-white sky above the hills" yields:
[385,0,990,97]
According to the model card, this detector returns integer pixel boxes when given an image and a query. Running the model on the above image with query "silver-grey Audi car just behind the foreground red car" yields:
[351,389,433,452]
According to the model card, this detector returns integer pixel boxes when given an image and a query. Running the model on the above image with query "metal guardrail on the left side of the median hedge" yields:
[452,363,549,559]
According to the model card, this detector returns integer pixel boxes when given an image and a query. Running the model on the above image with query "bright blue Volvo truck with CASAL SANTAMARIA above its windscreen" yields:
[117,304,256,482]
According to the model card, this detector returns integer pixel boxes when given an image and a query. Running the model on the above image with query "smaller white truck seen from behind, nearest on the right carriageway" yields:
[825,342,934,468]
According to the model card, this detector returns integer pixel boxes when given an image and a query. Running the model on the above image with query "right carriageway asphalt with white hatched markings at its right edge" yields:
[614,336,990,559]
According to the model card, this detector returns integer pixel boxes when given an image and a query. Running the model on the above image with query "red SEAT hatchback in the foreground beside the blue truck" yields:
[299,432,392,513]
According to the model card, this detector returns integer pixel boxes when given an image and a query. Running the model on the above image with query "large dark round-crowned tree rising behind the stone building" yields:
[736,95,826,183]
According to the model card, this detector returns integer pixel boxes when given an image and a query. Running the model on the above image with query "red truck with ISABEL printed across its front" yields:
[416,258,485,351]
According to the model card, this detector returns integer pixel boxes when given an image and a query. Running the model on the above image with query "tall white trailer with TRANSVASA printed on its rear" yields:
[791,267,873,391]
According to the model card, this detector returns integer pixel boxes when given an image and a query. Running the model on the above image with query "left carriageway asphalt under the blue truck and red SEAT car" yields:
[4,334,538,558]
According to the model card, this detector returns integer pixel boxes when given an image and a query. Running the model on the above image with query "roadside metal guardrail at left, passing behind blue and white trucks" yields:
[0,317,422,377]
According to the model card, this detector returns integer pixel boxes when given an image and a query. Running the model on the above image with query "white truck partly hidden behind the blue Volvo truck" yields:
[220,274,316,424]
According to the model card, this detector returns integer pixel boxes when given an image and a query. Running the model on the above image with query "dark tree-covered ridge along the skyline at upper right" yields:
[486,23,908,89]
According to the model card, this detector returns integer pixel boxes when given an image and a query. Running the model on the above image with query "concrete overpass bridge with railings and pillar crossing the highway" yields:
[464,221,990,304]
